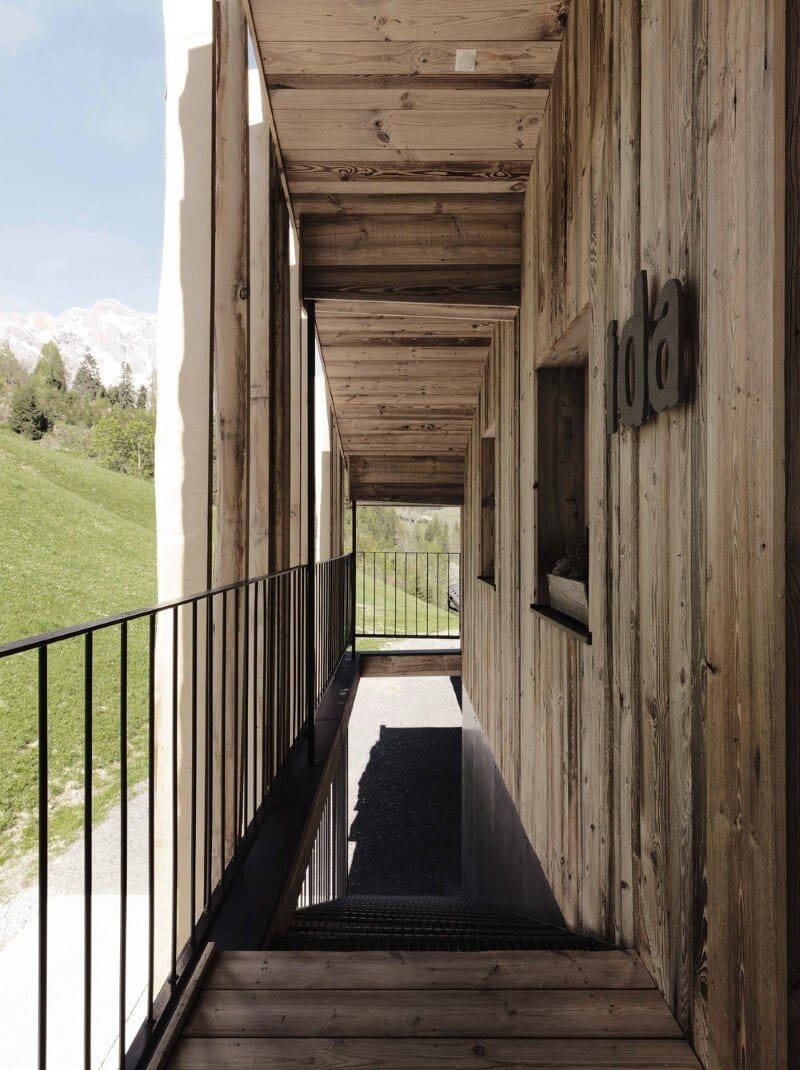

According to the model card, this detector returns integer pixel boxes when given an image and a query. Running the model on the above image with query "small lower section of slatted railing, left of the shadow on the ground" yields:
[297,729,350,910]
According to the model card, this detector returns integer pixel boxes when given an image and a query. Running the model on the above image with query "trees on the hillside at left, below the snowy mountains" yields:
[0,339,155,479]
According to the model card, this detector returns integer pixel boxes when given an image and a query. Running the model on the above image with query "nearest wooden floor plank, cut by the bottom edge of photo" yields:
[171,1038,699,1070]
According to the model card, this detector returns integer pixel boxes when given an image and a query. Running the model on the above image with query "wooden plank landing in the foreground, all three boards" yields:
[168,951,699,1070]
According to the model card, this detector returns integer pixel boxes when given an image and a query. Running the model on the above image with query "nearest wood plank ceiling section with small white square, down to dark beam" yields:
[251,0,565,304]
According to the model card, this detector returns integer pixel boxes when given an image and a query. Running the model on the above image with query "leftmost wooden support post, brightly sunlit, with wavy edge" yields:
[153,0,214,984]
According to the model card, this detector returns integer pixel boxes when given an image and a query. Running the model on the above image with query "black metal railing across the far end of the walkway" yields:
[355,550,461,639]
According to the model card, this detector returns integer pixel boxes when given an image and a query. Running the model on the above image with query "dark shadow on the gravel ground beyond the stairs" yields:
[348,725,461,896]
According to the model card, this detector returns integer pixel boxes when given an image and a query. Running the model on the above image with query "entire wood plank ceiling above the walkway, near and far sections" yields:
[251,0,566,500]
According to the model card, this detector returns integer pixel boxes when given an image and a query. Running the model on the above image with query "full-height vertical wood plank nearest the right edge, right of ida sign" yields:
[705,0,786,1068]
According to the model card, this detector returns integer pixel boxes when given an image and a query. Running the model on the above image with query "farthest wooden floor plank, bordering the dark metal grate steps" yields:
[205,951,656,990]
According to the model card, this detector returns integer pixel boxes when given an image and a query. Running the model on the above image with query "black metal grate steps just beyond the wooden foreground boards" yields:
[274,896,611,951]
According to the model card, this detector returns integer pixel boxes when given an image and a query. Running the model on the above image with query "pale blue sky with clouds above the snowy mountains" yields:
[0,0,164,314]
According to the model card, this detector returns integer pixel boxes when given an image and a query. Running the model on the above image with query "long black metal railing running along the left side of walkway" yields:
[0,555,353,1068]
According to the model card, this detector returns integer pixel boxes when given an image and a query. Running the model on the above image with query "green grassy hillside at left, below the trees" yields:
[0,429,156,861]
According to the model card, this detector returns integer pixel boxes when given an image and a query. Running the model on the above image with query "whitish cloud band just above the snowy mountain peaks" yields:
[0,223,160,315]
